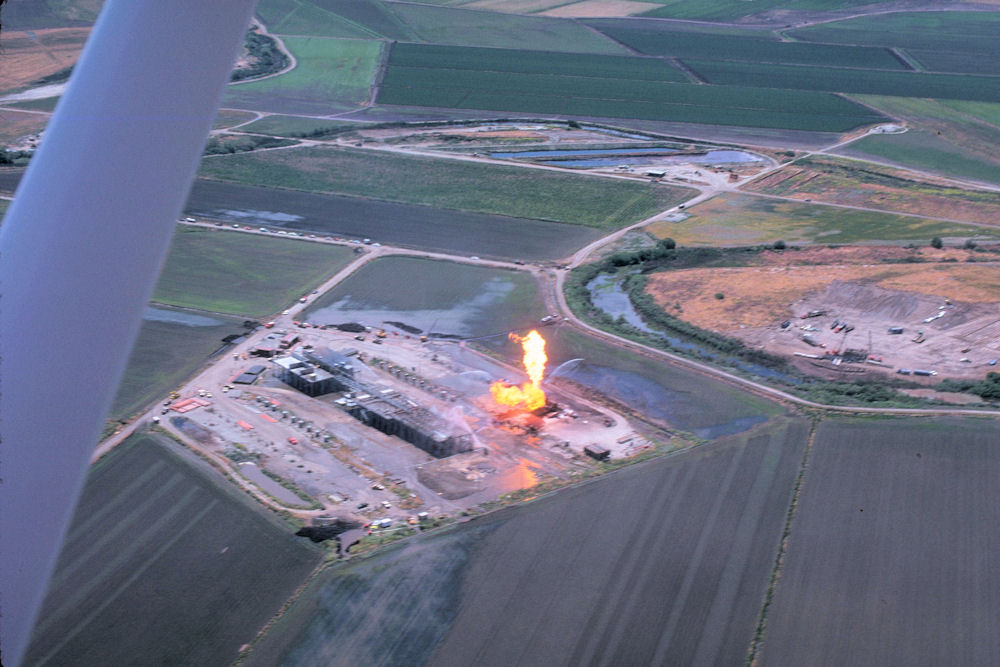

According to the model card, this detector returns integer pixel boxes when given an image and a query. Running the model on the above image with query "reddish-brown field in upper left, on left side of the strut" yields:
[0,28,90,93]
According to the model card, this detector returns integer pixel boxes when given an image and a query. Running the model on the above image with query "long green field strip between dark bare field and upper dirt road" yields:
[201,147,693,229]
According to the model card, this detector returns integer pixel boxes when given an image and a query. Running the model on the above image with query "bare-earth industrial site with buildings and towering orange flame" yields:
[156,310,651,547]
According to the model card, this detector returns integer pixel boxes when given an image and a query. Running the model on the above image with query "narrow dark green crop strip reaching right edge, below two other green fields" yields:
[684,60,1000,102]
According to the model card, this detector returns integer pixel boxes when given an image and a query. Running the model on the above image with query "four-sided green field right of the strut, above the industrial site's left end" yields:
[153,226,351,317]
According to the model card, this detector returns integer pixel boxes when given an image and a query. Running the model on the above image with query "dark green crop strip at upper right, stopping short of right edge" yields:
[589,21,906,70]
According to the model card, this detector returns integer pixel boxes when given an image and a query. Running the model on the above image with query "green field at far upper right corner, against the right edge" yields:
[786,11,1000,75]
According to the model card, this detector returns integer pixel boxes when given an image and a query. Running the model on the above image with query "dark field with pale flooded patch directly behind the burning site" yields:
[305,257,546,337]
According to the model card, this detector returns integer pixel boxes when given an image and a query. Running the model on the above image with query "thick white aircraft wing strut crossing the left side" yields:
[0,0,254,666]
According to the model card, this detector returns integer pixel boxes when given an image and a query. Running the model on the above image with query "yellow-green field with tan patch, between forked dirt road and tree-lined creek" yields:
[645,192,1000,246]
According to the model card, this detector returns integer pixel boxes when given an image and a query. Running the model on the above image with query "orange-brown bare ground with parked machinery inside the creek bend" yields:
[647,249,1000,378]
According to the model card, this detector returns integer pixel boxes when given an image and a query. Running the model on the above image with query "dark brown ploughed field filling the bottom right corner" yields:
[760,419,1000,665]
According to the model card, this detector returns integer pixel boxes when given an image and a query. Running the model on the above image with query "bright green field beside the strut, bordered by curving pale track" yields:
[222,37,382,114]
